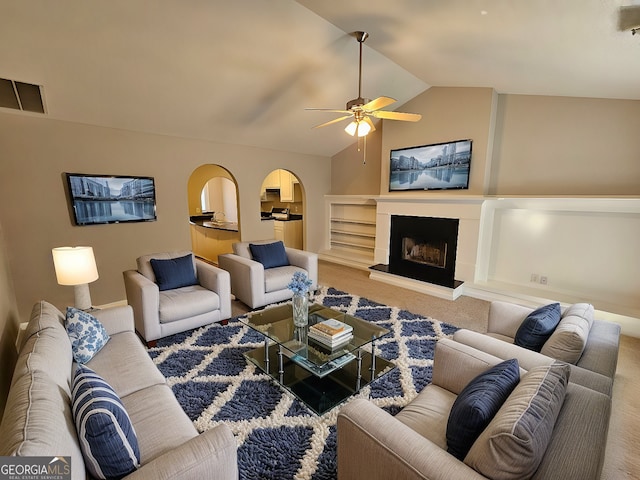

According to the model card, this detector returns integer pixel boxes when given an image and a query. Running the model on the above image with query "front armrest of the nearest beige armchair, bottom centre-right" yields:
[338,399,485,480]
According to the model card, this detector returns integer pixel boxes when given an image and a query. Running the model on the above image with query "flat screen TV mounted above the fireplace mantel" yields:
[389,140,472,192]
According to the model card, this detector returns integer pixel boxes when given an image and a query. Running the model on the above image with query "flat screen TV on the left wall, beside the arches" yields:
[65,173,156,225]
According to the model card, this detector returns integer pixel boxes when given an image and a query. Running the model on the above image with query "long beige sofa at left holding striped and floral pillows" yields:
[0,301,238,479]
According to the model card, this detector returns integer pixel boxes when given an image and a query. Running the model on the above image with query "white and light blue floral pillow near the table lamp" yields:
[64,307,109,363]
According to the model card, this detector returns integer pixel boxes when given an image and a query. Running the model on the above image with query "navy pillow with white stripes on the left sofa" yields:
[71,365,140,478]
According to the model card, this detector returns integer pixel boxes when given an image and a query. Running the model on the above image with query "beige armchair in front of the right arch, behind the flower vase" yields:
[218,240,318,308]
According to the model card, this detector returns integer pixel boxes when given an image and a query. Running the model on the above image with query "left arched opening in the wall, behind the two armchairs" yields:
[187,165,240,264]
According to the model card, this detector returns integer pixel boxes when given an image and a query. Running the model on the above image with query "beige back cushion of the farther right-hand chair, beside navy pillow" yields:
[540,304,593,365]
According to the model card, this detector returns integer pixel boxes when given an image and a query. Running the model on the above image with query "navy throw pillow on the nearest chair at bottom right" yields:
[447,358,520,460]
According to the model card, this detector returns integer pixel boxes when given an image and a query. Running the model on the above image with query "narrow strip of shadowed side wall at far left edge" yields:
[0,223,20,418]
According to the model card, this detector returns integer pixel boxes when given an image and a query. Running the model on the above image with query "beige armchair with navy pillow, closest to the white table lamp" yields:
[123,251,231,346]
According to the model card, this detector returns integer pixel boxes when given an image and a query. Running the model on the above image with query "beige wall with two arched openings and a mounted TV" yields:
[0,113,330,321]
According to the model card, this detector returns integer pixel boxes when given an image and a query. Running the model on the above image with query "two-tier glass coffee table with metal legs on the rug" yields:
[240,304,395,414]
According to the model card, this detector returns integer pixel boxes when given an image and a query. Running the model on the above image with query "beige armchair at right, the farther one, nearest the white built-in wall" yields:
[453,301,620,396]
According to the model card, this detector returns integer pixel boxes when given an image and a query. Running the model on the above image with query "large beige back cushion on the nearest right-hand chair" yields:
[464,362,571,479]
